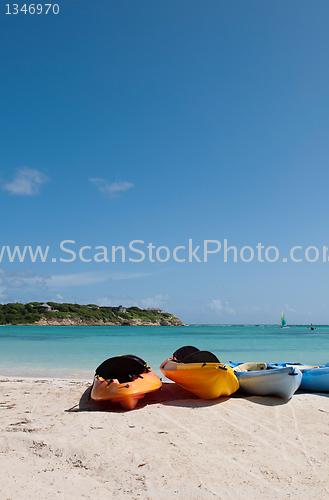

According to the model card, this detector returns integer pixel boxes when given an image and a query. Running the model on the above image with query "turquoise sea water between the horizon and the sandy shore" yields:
[0,325,329,379]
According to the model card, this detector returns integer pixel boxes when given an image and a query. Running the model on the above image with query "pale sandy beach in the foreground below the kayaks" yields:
[0,377,329,500]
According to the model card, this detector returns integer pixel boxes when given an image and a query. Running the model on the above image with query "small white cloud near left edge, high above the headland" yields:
[2,167,49,196]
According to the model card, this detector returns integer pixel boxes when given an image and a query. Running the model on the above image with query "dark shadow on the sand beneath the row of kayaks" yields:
[65,382,287,413]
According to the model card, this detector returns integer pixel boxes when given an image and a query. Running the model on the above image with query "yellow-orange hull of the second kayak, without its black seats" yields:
[160,358,239,399]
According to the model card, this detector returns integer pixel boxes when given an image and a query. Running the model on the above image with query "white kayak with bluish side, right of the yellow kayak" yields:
[234,363,302,399]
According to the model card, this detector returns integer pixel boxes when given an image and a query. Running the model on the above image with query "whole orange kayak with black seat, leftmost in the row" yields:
[90,355,162,410]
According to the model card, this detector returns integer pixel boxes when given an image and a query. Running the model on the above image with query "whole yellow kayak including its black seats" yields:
[160,346,239,399]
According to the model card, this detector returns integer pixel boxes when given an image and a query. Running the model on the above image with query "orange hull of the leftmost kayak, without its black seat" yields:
[90,370,162,410]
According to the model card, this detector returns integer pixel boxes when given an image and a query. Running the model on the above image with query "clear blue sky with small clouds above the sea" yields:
[0,0,329,324]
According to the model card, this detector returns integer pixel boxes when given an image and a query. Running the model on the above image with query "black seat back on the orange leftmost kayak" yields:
[95,354,149,384]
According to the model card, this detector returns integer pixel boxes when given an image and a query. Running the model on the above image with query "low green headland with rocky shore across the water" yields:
[0,302,183,325]
